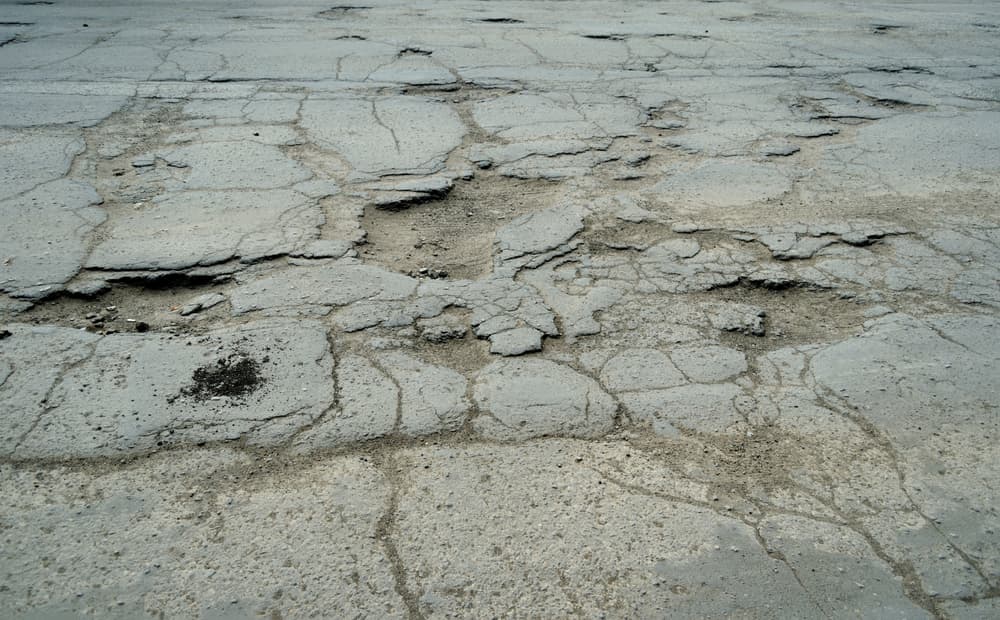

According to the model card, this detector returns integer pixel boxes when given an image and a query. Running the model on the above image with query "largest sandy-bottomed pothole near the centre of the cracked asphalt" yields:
[361,176,561,279]
